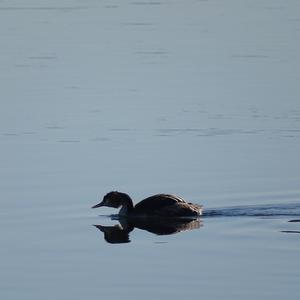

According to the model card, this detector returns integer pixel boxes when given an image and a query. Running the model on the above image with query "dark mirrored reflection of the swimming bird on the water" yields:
[94,217,201,244]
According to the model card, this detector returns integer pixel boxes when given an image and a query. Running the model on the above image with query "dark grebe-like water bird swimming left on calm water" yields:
[92,191,203,218]
